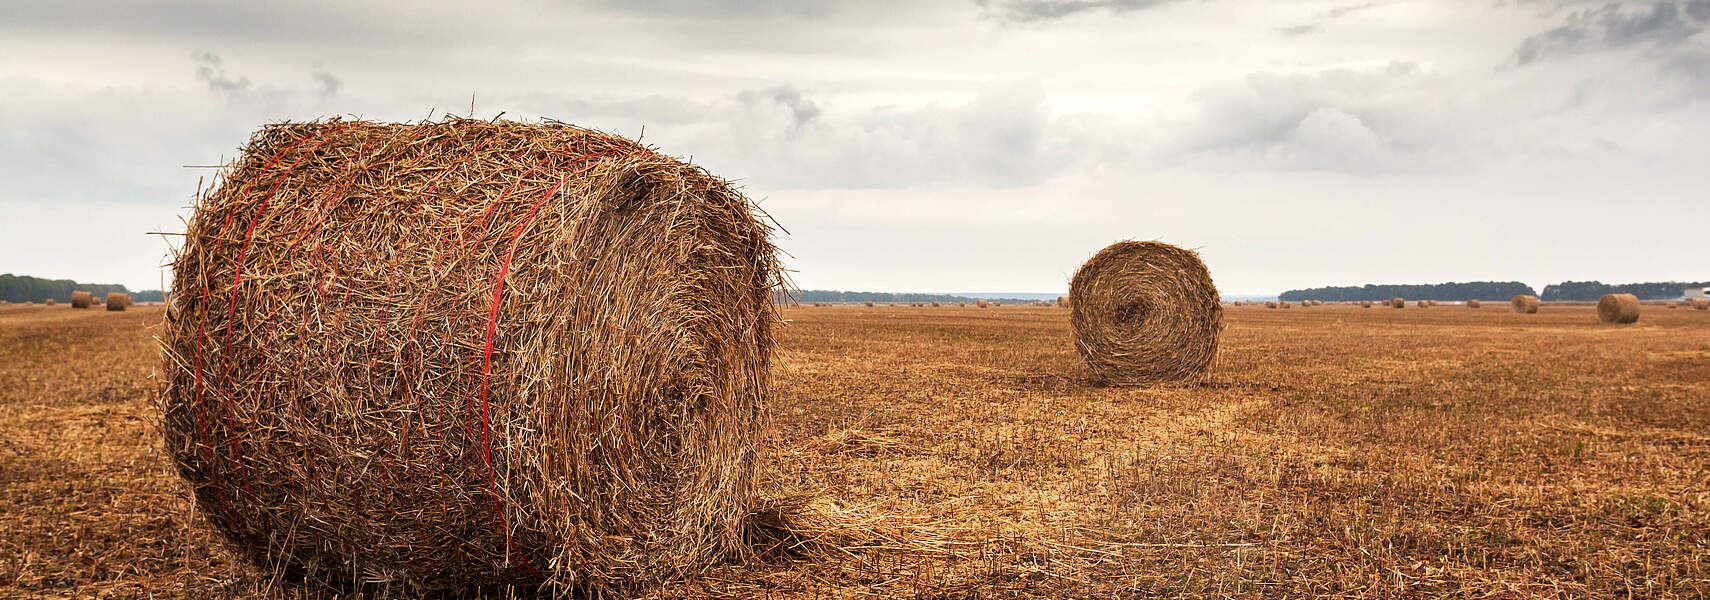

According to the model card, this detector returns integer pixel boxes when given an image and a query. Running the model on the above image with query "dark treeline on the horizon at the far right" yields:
[1279,282,1710,303]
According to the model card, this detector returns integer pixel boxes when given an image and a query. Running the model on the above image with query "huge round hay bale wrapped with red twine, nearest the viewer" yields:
[159,120,780,590]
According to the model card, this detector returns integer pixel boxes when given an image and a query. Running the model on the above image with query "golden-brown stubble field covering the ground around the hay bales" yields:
[0,303,1710,598]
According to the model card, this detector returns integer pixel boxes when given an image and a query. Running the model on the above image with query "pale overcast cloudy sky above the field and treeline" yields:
[0,0,1710,294]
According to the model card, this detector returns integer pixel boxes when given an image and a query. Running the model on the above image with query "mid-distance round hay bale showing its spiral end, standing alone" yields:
[1069,241,1223,385]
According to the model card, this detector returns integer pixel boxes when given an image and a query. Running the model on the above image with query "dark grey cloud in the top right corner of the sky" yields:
[1510,0,1710,65]
